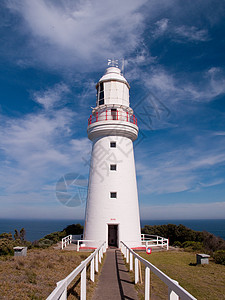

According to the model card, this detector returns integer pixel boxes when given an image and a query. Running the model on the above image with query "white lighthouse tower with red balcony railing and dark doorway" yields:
[84,61,141,247]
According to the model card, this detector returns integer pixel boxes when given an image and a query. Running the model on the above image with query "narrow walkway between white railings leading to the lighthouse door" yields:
[92,249,138,300]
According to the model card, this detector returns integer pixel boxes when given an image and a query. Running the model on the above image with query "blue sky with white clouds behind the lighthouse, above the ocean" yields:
[0,0,225,219]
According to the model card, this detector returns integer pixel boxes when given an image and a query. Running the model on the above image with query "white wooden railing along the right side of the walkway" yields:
[121,241,196,300]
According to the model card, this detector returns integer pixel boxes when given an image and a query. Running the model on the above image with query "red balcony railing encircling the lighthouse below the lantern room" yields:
[88,110,137,126]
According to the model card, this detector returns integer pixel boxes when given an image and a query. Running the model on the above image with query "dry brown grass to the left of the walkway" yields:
[0,249,90,300]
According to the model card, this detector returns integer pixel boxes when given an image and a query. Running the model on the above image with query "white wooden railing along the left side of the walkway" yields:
[46,242,106,300]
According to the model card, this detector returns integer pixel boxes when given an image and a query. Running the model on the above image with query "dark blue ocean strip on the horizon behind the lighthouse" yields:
[0,219,225,241]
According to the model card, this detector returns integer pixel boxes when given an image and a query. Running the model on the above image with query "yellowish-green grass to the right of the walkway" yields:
[134,251,225,300]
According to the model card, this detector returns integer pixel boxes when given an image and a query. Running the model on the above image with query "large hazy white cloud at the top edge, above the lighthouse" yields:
[6,0,146,71]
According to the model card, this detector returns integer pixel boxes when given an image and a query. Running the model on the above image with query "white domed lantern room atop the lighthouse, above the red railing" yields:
[96,67,130,107]
